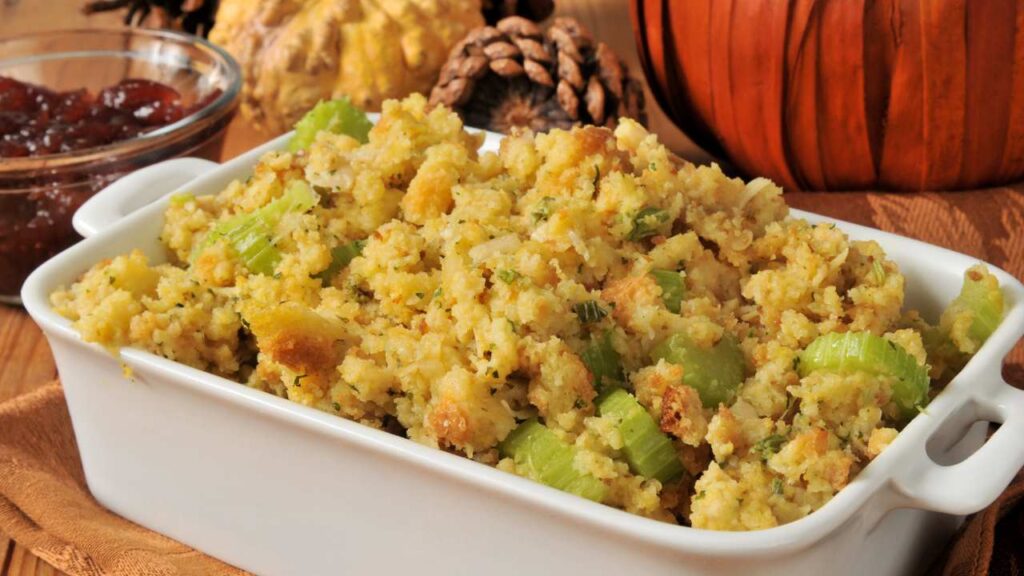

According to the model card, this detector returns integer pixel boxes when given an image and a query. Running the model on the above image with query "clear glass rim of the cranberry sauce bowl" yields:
[0,27,242,172]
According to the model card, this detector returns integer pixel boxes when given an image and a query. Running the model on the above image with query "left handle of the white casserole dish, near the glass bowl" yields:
[72,158,219,238]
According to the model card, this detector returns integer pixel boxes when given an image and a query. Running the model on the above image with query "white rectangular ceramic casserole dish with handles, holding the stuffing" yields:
[22,125,1024,576]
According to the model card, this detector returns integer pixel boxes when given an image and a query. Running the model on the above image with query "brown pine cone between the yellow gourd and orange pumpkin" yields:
[430,16,646,132]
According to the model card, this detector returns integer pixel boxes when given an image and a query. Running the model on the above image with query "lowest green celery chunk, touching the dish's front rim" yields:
[499,418,607,502]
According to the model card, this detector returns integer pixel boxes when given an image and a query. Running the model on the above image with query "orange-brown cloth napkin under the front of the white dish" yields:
[0,383,1024,576]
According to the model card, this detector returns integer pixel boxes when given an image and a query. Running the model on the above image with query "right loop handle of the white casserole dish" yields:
[894,378,1024,516]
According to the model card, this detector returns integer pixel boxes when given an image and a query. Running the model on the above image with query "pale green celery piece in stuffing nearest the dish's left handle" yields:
[193,180,317,276]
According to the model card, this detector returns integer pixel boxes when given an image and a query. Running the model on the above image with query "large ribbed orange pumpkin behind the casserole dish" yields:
[631,0,1024,190]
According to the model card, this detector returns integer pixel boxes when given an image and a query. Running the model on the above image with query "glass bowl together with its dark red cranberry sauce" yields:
[0,29,241,303]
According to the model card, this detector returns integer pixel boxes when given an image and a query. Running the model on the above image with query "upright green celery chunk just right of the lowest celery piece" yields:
[597,388,683,483]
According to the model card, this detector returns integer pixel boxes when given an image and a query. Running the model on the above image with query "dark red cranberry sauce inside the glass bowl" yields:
[0,76,221,302]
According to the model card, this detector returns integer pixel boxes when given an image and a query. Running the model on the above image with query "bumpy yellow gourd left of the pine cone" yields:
[210,0,483,133]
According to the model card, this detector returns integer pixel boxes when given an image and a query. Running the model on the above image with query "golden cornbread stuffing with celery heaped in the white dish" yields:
[51,95,1001,530]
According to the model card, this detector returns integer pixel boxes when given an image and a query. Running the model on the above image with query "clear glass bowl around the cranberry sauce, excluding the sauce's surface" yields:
[0,28,242,303]
